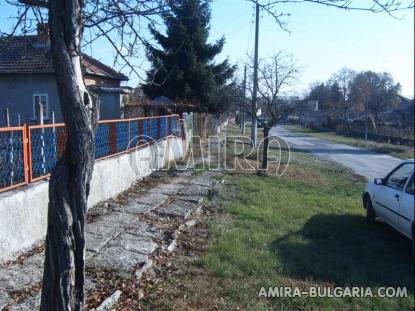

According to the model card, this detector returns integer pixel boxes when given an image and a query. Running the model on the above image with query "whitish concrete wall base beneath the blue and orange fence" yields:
[0,137,187,263]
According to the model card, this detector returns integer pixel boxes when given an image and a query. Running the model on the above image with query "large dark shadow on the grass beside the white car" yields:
[271,214,414,293]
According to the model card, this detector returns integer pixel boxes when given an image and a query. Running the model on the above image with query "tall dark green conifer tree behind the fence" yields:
[143,0,235,112]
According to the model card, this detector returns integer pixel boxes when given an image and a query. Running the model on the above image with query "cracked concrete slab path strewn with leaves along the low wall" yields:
[0,171,218,310]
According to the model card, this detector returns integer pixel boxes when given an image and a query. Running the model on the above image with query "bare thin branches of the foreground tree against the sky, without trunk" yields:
[1,0,170,82]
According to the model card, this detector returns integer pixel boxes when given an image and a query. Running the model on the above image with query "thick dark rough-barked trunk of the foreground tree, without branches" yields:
[41,0,99,310]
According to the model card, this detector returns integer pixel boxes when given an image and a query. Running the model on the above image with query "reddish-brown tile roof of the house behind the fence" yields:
[0,36,128,80]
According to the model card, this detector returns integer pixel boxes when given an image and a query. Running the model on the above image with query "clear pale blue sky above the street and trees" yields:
[0,0,414,97]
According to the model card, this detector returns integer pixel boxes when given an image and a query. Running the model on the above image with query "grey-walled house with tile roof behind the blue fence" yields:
[0,27,128,126]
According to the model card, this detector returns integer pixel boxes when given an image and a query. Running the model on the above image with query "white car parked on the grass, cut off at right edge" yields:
[363,160,415,248]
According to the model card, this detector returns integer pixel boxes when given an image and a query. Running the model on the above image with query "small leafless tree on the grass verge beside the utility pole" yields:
[245,51,301,170]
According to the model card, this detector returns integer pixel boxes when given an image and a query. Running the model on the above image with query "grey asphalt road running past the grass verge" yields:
[271,126,402,180]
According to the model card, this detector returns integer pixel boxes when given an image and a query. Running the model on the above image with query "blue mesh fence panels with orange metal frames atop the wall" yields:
[0,115,182,192]
